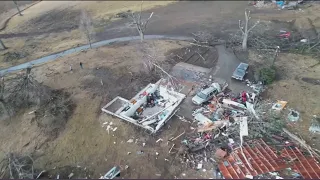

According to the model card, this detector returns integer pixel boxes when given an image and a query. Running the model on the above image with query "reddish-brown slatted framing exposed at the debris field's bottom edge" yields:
[218,139,320,179]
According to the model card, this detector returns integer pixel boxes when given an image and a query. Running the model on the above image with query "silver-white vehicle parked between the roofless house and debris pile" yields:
[192,83,221,105]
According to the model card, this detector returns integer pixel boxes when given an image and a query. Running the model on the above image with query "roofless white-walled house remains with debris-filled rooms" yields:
[102,79,186,133]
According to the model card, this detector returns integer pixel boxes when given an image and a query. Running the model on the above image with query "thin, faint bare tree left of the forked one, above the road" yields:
[79,10,94,48]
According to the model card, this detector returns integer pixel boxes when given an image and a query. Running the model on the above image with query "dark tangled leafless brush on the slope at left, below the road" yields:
[0,68,74,136]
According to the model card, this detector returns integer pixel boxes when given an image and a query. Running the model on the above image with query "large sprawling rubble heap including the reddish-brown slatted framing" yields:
[181,82,320,179]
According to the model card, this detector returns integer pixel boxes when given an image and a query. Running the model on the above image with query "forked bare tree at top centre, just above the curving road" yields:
[128,1,153,42]
